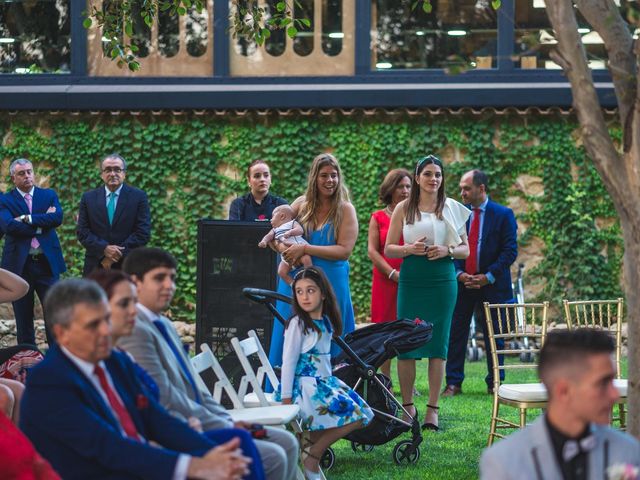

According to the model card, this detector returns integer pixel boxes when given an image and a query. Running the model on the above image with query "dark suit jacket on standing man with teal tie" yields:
[76,183,151,275]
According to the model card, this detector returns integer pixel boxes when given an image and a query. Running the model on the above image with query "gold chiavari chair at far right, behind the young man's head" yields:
[562,298,627,430]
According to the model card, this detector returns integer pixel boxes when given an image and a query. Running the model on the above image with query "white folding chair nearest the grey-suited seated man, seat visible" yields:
[191,343,300,426]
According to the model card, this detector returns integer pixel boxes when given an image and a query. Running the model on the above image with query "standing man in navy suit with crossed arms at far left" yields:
[0,158,67,344]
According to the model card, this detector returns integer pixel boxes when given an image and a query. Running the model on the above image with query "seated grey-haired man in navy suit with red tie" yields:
[20,279,251,480]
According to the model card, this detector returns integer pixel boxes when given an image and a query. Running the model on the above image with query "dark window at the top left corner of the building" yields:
[0,0,71,73]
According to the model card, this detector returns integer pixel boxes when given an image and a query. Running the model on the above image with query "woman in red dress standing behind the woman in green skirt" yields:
[368,168,411,377]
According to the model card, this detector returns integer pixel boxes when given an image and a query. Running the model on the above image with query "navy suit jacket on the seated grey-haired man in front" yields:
[20,344,214,480]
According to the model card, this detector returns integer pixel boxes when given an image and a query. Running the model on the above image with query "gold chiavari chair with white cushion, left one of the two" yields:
[484,302,549,445]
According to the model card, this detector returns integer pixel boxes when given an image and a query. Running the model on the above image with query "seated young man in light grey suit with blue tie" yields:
[118,247,299,480]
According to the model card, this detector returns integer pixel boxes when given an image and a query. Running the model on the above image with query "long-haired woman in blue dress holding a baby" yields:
[269,153,358,365]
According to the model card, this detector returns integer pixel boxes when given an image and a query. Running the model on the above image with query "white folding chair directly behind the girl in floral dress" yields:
[231,330,280,407]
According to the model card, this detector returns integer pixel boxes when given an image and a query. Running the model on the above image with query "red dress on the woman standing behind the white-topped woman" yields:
[371,210,404,323]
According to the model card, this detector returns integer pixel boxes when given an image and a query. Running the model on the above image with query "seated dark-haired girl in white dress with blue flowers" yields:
[276,267,373,480]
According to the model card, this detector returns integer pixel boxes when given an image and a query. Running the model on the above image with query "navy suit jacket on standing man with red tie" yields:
[455,200,518,301]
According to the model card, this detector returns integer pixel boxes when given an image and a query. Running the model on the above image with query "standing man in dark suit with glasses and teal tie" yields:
[77,153,151,276]
